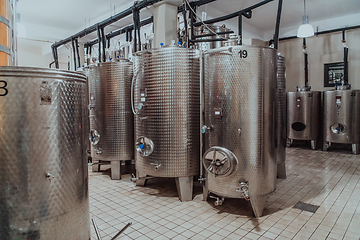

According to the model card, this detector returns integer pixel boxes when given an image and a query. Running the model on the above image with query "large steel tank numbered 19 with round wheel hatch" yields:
[201,46,277,217]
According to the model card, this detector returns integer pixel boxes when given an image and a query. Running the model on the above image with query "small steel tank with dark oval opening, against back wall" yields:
[287,86,321,149]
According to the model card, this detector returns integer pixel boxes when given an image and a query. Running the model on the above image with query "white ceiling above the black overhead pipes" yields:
[18,0,360,44]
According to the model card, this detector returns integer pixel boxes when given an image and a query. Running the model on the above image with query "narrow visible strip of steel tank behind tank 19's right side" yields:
[275,54,286,178]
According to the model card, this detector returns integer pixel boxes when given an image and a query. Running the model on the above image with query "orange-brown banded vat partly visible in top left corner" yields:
[0,0,17,66]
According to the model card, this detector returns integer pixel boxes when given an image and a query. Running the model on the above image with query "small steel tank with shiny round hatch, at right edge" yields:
[324,85,360,154]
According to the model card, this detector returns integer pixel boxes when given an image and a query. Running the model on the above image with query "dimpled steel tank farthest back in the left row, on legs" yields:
[89,60,134,179]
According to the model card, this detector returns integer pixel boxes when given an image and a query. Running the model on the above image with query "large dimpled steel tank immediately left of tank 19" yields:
[133,47,200,201]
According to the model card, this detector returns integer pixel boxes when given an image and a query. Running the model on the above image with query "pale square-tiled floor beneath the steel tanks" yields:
[89,148,360,240]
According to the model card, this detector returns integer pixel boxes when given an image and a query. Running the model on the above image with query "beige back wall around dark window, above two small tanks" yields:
[279,29,360,91]
